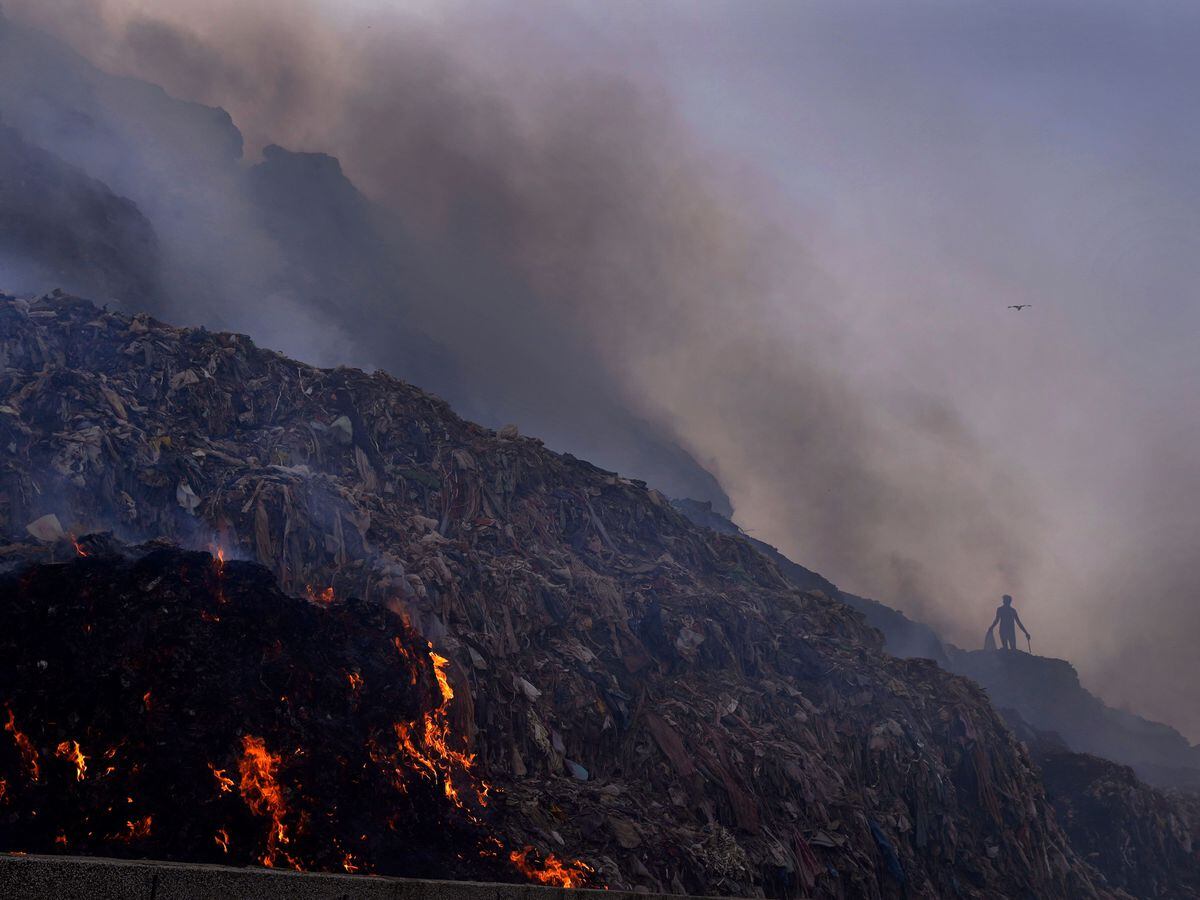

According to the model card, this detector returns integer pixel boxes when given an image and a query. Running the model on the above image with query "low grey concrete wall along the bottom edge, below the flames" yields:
[0,854,679,900]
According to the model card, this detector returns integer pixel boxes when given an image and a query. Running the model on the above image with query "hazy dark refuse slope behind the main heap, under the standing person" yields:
[672,489,1200,898]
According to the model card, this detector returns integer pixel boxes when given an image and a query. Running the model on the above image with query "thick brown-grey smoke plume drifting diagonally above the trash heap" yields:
[7,0,1200,733]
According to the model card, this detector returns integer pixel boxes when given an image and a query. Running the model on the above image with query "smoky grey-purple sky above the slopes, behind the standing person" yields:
[7,0,1200,740]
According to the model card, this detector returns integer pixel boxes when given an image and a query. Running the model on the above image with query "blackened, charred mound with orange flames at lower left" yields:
[0,547,515,881]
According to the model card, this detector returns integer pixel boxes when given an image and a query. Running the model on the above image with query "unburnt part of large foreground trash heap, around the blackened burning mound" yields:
[0,296,1117,898]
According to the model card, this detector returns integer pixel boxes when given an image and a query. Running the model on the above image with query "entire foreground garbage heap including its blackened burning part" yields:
[0,296,1161,898]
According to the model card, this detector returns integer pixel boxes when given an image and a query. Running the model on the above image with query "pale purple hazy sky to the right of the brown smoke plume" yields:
[576,0,1200,739]
